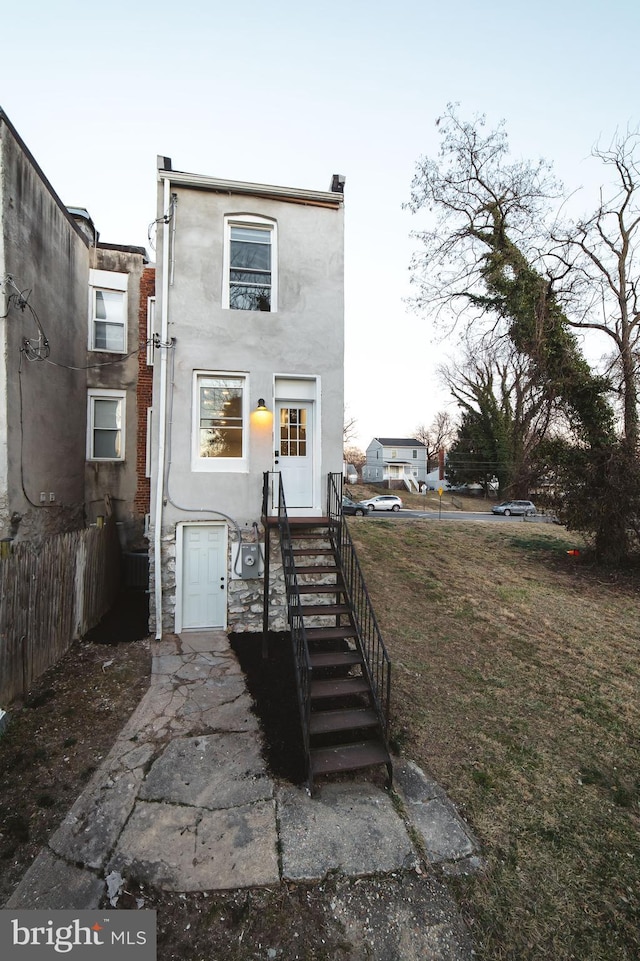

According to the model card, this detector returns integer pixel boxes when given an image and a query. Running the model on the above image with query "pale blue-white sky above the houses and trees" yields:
[0,0,640,449]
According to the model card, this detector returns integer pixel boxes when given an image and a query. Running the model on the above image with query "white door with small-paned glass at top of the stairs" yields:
[275,401,313,510]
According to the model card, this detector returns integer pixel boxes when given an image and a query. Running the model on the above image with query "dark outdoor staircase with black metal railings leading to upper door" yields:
[262,475,393,791]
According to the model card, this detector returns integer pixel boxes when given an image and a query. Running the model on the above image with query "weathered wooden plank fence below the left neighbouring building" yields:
[0,519,121,707]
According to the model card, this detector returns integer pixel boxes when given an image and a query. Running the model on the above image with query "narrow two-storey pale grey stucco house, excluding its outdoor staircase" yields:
[150,157,344,635]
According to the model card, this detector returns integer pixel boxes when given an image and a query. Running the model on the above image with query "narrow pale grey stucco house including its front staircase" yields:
[149,157,392,789]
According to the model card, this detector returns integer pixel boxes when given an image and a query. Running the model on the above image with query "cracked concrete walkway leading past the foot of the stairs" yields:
[6,632,480,959]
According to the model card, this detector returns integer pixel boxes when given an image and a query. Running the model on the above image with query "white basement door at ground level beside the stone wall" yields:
[182,524,227,630]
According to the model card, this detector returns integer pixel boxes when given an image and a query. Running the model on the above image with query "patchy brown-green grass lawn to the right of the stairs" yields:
[350,518,640,961]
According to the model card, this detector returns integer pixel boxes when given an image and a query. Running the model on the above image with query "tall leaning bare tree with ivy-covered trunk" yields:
[410,107,640,563]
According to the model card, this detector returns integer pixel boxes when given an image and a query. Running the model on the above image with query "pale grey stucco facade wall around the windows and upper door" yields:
[152,173,344,630]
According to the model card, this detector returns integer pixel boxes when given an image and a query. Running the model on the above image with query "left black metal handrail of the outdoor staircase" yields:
[272,474,313,785]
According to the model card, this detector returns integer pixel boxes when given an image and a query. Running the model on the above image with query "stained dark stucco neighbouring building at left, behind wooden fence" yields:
[0,110,154,548]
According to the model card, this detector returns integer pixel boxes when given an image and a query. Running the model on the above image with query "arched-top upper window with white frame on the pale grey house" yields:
[222,215,277,312]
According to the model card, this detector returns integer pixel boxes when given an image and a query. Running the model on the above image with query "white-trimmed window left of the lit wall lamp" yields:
[193,371,248,470]
